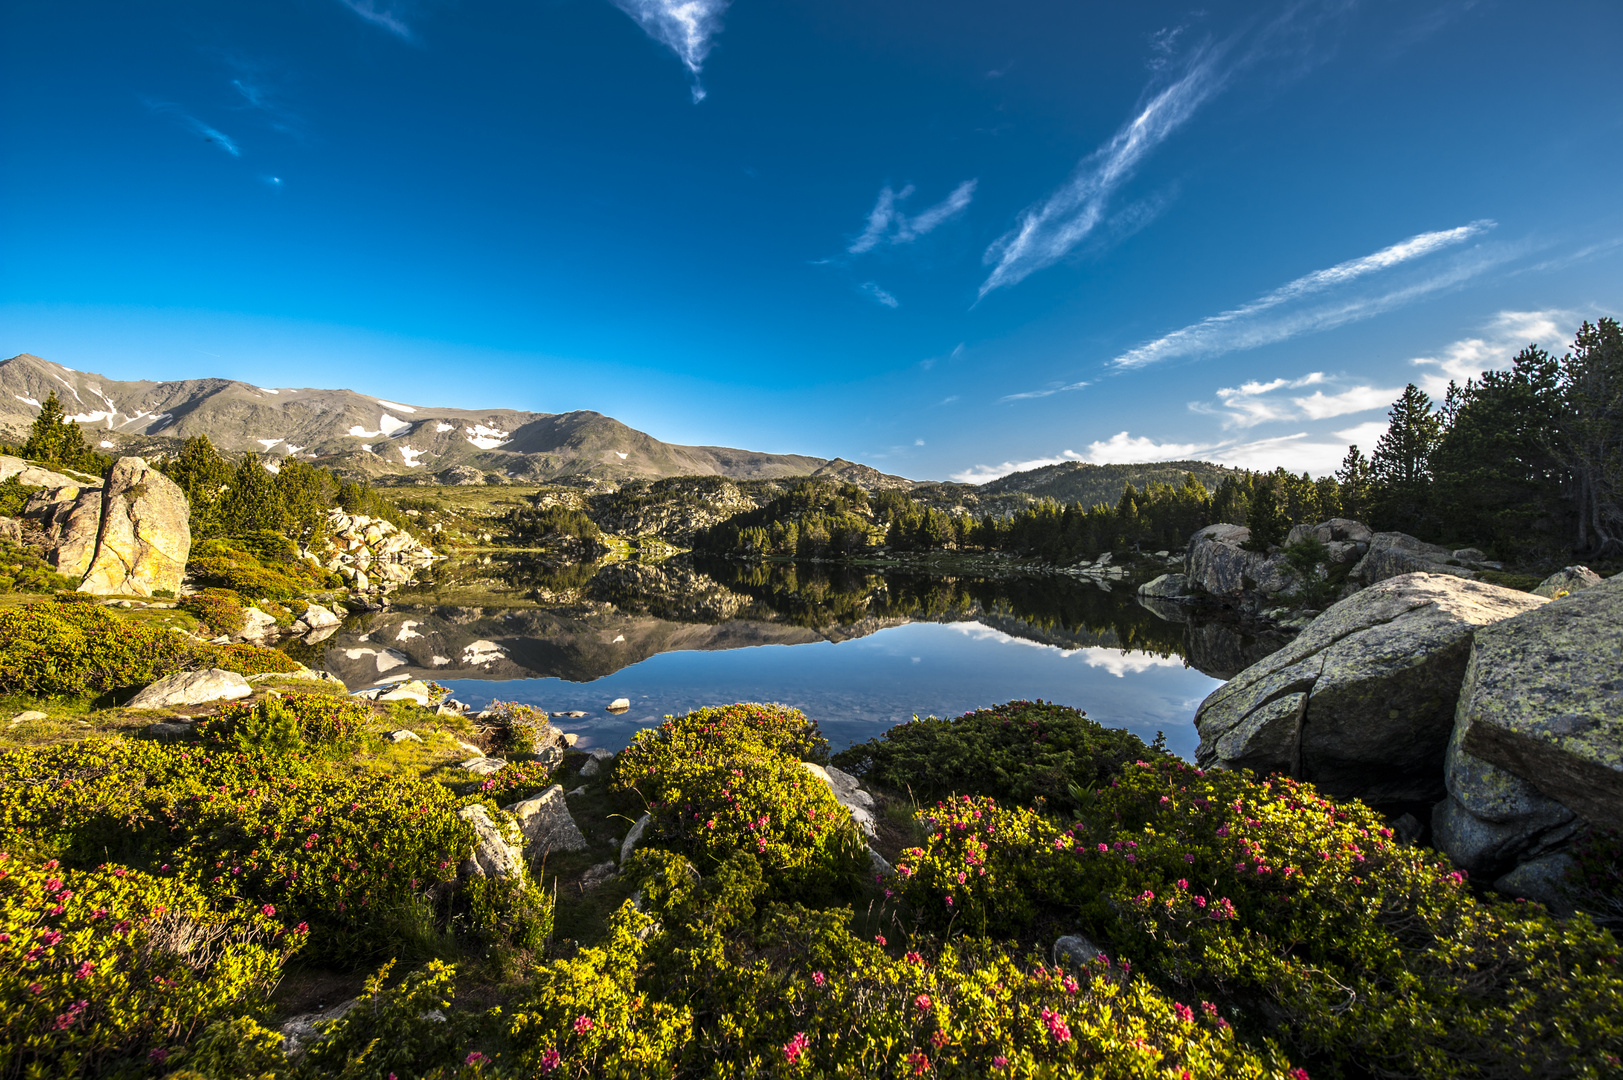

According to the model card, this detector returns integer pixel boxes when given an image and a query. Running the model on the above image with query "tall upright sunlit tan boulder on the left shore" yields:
[80,458,192,596]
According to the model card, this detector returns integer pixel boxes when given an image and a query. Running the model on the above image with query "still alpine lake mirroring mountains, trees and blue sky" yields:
[284,552,1282,758]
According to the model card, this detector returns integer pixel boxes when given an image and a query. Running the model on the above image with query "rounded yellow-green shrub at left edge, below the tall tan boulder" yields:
[0,594,188,695]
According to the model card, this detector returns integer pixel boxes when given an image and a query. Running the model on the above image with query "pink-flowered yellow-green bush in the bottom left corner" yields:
[0,854,305,1077]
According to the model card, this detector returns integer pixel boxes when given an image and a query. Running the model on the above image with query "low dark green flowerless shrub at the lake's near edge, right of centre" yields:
[833,702,1165,812]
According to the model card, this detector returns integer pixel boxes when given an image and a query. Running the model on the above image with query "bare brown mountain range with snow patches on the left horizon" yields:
[0,352,909,486]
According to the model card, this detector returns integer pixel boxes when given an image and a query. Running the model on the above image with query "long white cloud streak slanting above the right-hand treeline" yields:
[1110,221,1509,369]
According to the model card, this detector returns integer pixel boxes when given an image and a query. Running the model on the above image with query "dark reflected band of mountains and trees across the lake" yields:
[297,555,1276,685]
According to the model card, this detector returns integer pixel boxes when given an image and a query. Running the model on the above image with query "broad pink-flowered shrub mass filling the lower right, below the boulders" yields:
[896,762,1623,1077]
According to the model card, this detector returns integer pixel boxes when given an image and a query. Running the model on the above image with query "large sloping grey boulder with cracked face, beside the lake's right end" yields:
[1195,573,1545,802]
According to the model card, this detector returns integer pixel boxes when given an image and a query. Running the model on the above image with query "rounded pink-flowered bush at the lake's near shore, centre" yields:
[615,705,867,896]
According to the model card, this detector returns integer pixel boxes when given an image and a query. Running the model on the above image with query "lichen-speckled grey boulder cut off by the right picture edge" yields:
[1456,578,1623,828]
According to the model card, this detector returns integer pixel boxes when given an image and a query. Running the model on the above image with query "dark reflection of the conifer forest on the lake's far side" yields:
[700,560,1183,656]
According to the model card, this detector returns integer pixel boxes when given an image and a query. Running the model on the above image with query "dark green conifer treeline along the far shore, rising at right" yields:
[695,318,1623,564]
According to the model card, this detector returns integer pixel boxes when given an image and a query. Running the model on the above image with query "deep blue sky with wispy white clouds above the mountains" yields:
[0,0,1623,479]
